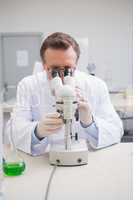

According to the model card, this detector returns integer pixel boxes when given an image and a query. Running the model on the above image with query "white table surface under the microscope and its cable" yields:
[5,143,133,200]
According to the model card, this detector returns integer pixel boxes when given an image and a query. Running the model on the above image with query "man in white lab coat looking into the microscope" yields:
[7,32,123,155]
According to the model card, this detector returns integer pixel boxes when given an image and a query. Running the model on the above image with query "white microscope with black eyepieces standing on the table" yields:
[49,68,88,166]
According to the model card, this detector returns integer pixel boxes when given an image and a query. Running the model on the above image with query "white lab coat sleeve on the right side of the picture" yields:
[85,81,123,149]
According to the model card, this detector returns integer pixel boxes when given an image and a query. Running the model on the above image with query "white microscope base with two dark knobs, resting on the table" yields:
[49,140,88,166]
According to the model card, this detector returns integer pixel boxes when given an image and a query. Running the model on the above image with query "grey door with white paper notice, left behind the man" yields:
[2,33,42,101]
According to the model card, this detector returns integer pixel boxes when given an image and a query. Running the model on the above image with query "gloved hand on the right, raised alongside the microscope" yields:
[76,87,93,125]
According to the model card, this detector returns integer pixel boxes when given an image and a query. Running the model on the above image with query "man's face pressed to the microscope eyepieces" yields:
[43,47,77,80]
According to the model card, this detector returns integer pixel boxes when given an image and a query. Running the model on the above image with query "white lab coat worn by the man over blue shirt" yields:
[7,70,123,153]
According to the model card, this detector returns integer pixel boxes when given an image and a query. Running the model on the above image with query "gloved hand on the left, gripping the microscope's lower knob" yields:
[36,112,64,139]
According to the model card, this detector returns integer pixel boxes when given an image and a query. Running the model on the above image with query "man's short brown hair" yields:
[40,32,80,62]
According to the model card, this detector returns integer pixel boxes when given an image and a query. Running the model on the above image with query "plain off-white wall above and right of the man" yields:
[0,0,133,88]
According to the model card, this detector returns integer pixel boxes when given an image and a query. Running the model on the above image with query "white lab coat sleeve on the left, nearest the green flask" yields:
[6,78,48,154]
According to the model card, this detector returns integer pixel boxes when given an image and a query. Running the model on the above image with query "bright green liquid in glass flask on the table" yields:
[3,161,25,176]
